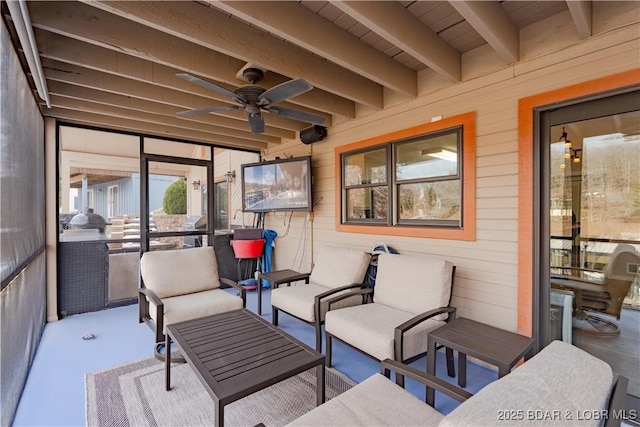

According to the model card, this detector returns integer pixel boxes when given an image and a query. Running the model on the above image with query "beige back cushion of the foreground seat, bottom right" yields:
[441,341,614,427]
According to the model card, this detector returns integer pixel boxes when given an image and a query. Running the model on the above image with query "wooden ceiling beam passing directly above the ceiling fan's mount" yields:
[80,1,383,109]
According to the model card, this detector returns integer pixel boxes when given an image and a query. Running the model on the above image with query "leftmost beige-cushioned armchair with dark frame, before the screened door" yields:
[138,246,246,356]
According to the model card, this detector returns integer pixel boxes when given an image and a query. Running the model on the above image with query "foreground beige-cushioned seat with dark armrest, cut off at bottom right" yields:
[290,341,632,427]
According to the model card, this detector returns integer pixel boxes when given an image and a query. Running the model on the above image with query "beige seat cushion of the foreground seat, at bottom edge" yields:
[289,374,442,426]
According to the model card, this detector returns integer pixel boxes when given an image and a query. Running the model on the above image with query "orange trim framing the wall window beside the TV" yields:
[335,112,476,241]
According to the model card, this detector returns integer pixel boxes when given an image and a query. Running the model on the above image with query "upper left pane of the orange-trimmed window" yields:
[344,148,387,187]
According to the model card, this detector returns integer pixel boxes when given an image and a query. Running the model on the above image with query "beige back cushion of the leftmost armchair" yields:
[140,246,220,298]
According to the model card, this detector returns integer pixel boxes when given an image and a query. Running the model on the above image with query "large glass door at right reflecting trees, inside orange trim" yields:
[539,91,640,408]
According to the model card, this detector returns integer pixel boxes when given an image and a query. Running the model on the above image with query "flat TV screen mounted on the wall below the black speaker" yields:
[242,156,313,212]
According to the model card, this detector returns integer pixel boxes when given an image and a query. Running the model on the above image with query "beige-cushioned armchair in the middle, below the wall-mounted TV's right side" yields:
[271,246,371,351]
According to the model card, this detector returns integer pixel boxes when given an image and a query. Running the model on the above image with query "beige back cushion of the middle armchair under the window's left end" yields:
[309,246,371,289]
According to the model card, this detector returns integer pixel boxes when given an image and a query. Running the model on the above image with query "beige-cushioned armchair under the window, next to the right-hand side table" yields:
[325,254,456,375]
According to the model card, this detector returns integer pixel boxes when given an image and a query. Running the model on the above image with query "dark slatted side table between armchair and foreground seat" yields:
[427,317,534,406]
